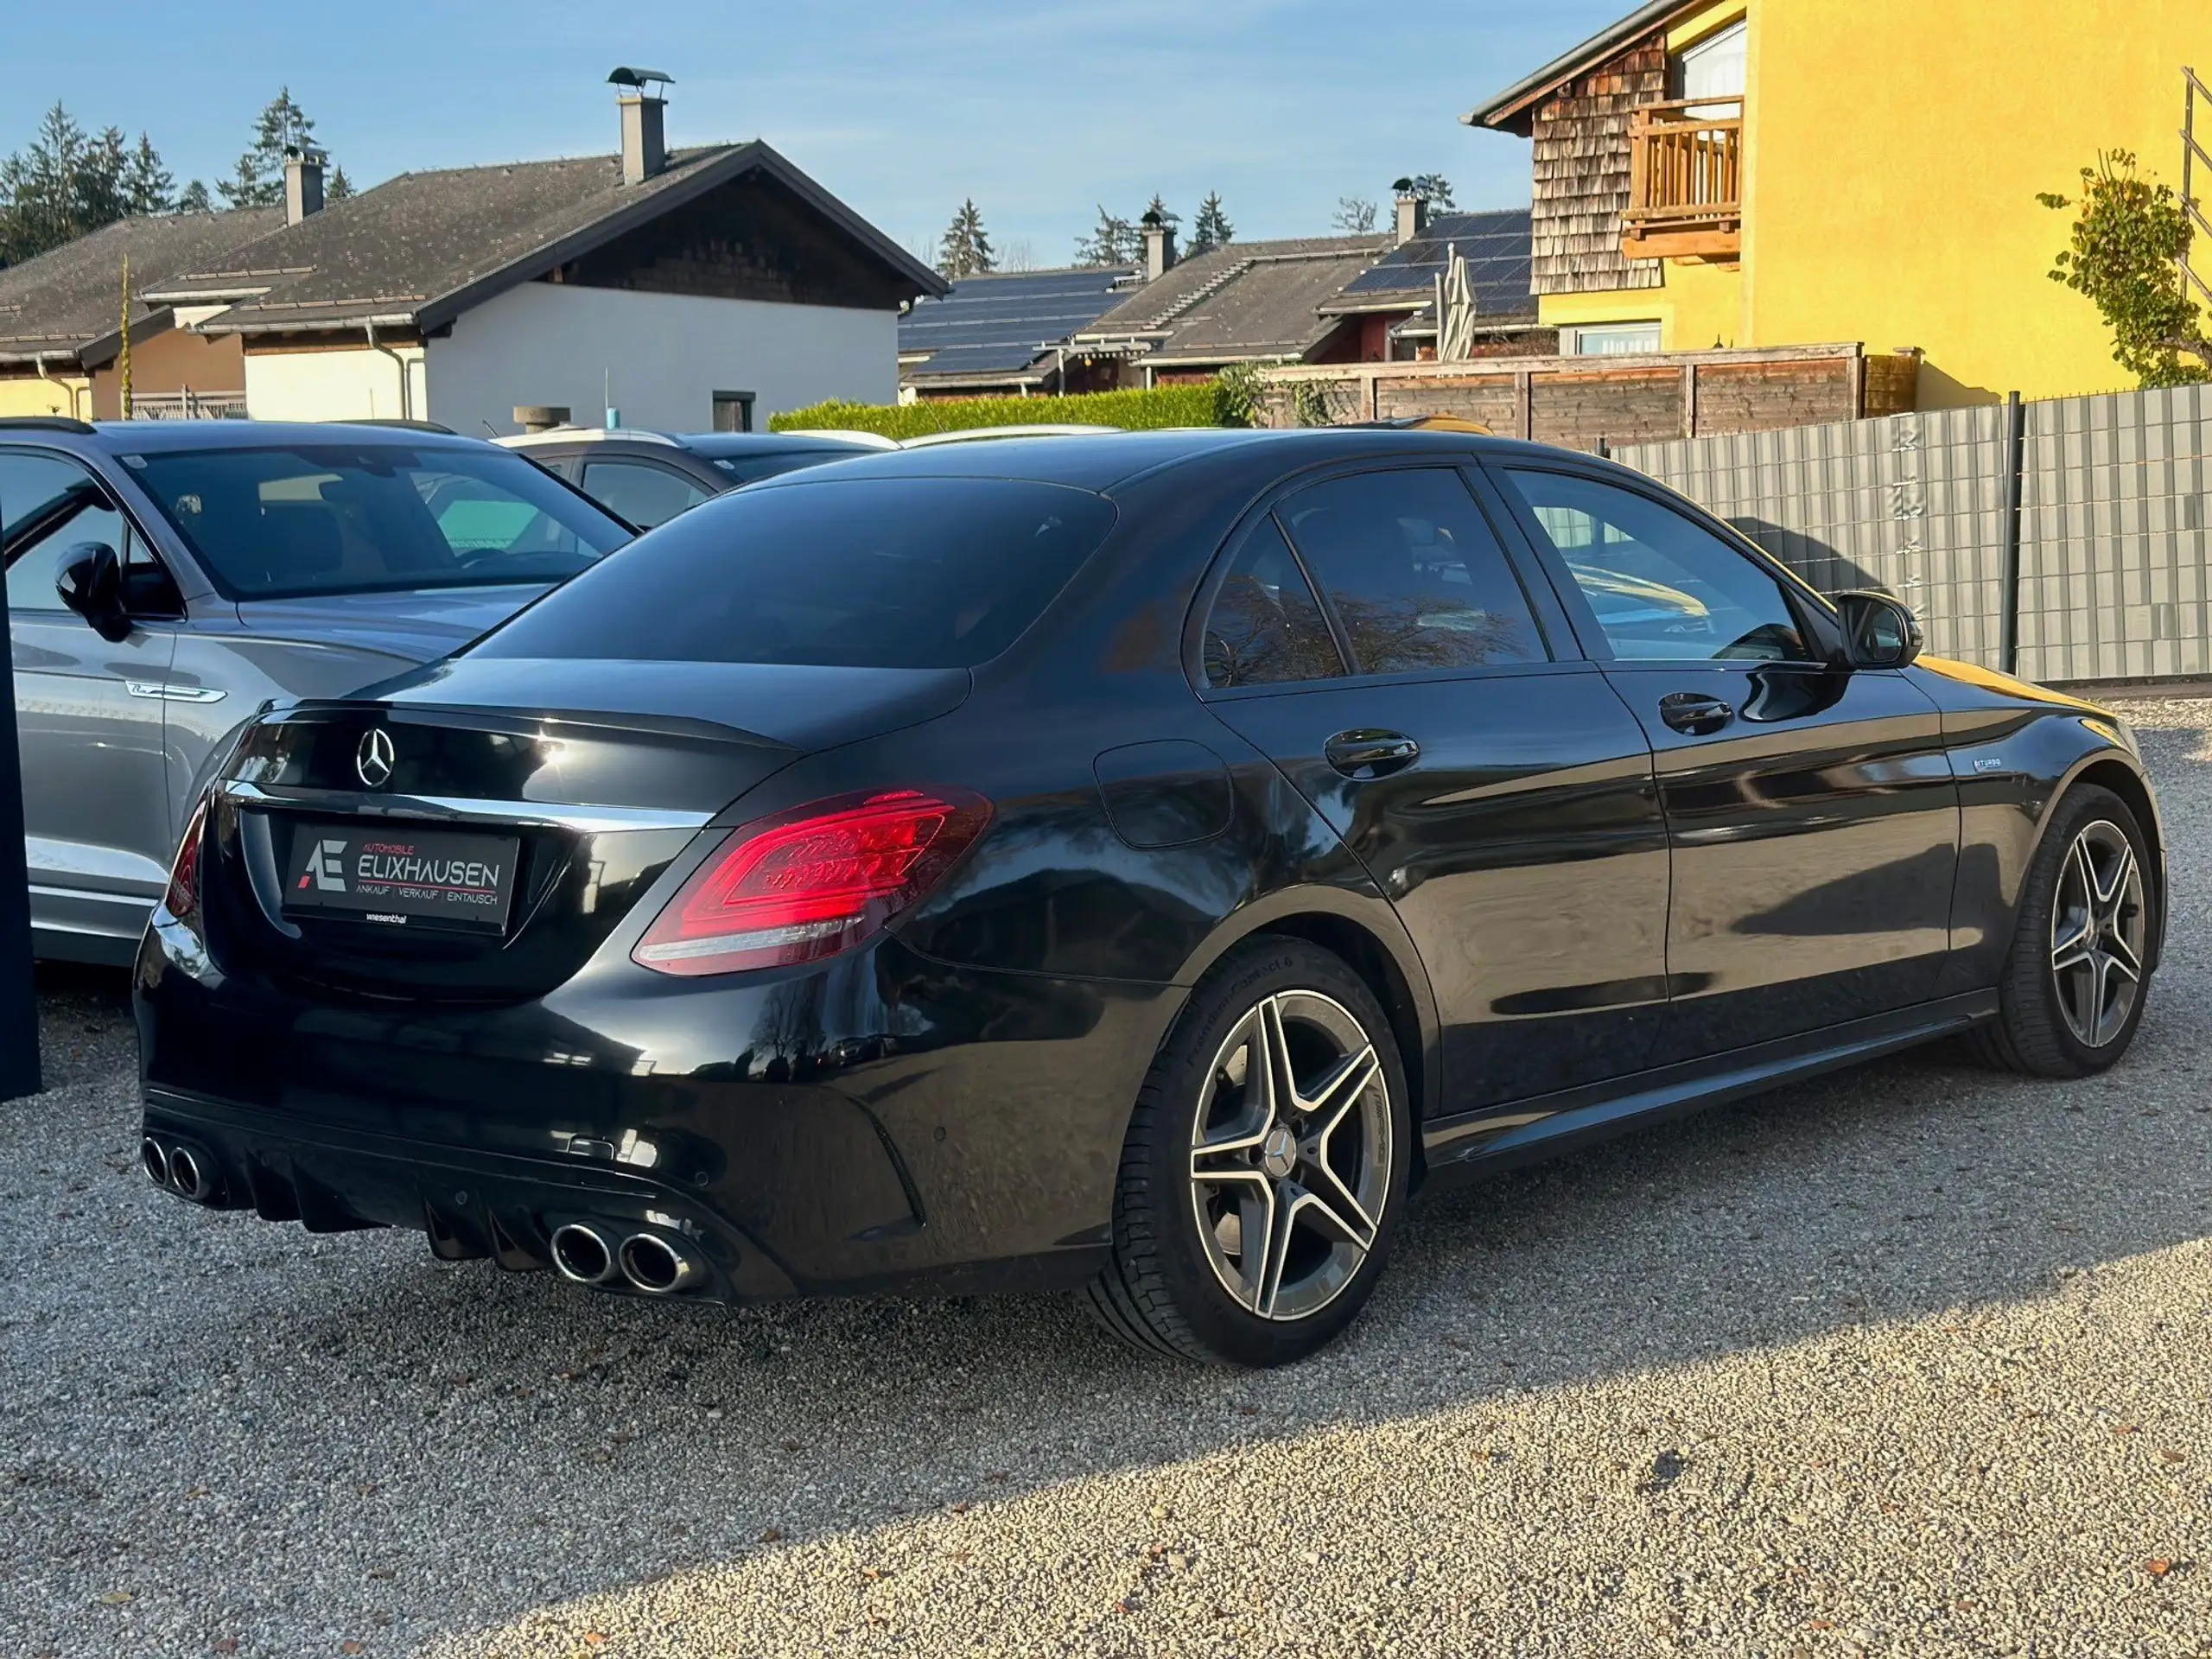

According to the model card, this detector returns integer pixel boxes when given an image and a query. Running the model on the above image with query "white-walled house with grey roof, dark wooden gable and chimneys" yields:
[0,68,947,435]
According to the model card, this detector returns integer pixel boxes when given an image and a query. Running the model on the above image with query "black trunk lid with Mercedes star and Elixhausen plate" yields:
[201,657,969,1000]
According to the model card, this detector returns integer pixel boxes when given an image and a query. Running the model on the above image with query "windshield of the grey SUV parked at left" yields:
[124,442,631,600]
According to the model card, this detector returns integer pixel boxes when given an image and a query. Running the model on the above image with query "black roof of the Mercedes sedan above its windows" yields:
[750,427,1591,491]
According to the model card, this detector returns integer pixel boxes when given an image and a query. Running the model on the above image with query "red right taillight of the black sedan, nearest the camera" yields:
[631,790,991,973]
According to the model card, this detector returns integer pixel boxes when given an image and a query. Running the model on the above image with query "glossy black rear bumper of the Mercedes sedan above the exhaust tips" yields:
[135,916,1181,1300]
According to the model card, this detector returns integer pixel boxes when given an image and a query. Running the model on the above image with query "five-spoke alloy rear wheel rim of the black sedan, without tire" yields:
[1190,991,1394,1319]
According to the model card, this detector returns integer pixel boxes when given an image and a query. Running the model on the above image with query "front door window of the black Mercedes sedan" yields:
[1502,471,1814,661]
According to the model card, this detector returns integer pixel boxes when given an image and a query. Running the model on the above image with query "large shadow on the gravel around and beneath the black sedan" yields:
[0,730,2212,1652]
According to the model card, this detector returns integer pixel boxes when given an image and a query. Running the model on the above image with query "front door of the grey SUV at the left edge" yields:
[0,447,177,960]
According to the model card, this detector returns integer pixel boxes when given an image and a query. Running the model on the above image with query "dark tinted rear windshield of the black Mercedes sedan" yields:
[475,478,1115,668]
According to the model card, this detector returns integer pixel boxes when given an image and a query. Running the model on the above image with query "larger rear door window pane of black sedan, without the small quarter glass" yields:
[1276,467,1546,675]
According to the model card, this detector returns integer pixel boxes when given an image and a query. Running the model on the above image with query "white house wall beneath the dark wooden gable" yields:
[422,283,898,438]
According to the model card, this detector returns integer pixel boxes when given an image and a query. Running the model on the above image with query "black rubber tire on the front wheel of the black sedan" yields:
[1971,785,2159,1077]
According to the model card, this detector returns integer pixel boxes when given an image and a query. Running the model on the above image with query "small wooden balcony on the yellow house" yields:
[1621,98,1743,261]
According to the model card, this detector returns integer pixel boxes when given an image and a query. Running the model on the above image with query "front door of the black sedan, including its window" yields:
[1497,467,1960,1058]
